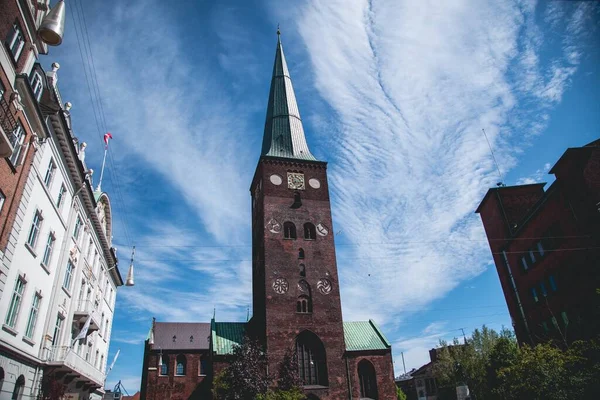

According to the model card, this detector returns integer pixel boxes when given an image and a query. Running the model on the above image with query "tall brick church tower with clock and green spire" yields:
[250,32,349,400]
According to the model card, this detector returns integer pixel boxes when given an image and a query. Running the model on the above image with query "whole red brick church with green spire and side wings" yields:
[141,33,396,400]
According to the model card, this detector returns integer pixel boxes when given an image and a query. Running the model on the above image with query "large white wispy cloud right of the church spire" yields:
[278,0,592,332]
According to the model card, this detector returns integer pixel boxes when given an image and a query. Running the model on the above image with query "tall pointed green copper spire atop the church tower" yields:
[261,31,316,161]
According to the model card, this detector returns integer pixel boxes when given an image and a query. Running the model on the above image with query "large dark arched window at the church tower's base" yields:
[296,331,328,386]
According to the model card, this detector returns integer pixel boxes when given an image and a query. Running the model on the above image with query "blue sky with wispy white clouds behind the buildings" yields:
[42,0,600,392]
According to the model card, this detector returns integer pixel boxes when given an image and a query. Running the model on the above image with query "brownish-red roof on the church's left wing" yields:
[154,322,210,350]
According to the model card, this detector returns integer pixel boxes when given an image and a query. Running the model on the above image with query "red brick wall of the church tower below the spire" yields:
[251,158,348,400]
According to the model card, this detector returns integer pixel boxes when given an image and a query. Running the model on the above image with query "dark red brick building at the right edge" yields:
[477,140,600,345]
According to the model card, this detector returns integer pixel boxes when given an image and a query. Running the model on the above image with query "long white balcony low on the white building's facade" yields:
[46,346,105,390]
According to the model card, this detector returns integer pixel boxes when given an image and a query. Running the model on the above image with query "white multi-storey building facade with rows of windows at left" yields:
[0,58,123,400]
